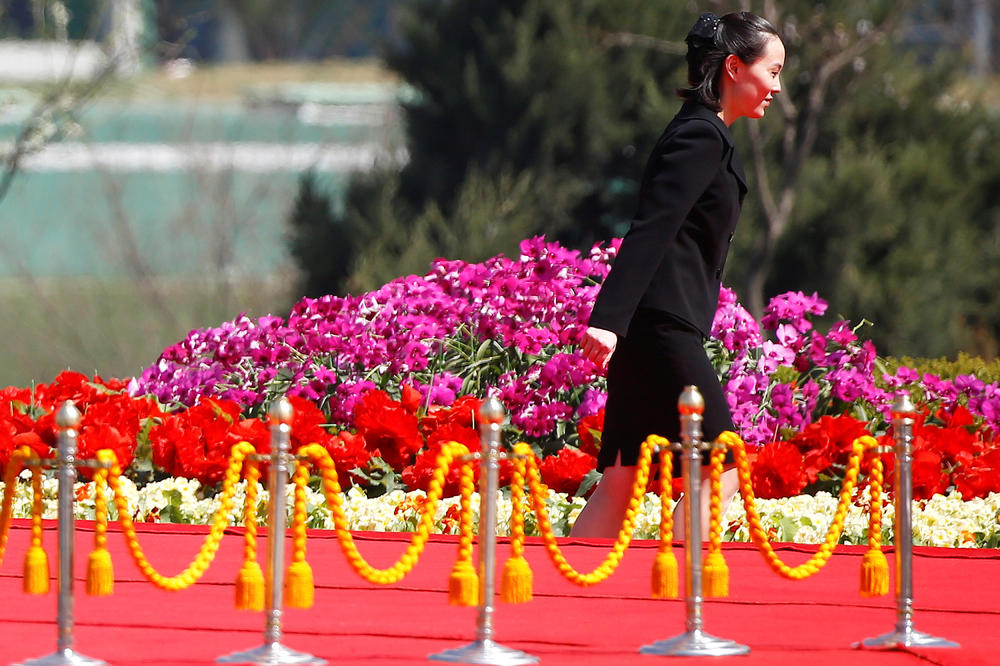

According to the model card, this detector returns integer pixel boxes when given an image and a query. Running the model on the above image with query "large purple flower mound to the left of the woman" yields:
[132,238,618,435]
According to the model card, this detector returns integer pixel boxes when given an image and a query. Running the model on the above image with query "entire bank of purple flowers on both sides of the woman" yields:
[130,233,1000,444]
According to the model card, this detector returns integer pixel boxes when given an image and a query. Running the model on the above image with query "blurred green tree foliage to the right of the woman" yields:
[730,2,1000,357]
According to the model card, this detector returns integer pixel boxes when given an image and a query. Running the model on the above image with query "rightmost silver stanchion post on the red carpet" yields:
[861,394,960,649]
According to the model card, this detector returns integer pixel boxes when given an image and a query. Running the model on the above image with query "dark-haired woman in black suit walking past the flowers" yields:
[572,12,785,538]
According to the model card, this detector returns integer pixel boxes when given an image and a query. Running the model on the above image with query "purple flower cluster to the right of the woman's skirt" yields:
[707,288,1000,445]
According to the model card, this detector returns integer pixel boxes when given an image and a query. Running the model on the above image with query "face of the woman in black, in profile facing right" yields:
[723,35,785,119]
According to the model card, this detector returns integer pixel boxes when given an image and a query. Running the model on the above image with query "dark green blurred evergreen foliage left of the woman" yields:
[292,0,699,291]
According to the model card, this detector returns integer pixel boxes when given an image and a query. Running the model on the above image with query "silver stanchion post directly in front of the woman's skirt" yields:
[639,386,750,657]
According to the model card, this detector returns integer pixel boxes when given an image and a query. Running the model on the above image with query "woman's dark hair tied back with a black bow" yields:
[677,12,778,111]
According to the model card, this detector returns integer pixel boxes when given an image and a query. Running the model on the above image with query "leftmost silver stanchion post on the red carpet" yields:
[23,400,107,666]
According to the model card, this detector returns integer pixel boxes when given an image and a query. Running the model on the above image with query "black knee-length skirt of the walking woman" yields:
[597,309,733,476]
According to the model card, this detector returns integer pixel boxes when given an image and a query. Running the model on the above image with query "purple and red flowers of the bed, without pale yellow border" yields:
[0,238,1000,544]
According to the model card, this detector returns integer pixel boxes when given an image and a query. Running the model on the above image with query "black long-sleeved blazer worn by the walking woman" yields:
[590,101,747,337]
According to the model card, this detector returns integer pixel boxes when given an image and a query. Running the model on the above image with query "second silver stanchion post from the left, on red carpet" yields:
[216,398,326,665]
